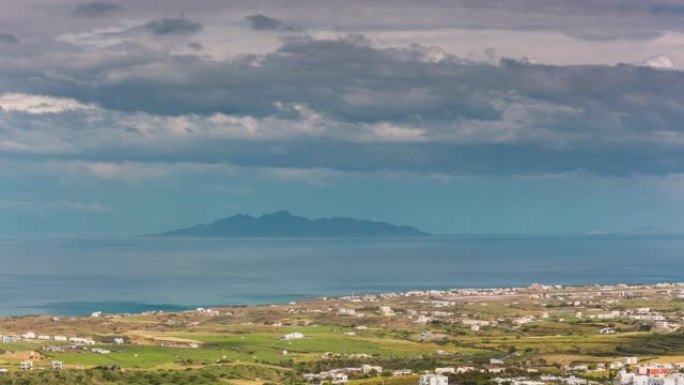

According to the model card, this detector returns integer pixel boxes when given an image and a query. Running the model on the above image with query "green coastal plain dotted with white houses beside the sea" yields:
[0,283,684,385]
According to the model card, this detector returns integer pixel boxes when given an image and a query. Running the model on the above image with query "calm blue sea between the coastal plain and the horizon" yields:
[0,236,684,315]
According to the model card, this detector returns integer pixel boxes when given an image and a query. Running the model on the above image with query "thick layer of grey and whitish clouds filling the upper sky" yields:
[0,0,684,175]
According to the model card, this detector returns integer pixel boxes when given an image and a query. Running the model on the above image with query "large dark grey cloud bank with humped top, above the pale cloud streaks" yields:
[13,38,684,126]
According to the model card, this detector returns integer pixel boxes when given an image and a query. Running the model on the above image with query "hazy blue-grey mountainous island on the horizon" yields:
[152,211,430,238]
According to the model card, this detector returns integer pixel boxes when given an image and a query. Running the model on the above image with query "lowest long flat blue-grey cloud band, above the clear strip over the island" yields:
[8,139,684,177]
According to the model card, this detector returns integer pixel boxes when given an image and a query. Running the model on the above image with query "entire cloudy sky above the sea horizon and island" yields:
[0,0,684,236]
